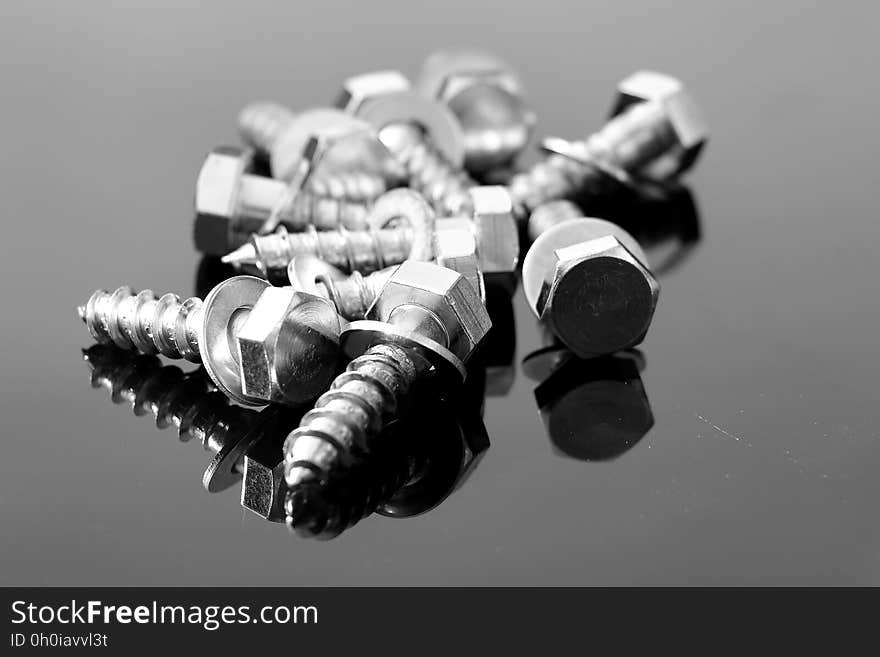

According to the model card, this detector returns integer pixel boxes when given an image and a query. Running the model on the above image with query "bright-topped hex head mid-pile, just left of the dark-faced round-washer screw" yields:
[469,185,519,274]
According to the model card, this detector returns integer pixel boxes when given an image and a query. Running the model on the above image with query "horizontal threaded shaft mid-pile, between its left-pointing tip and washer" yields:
[253,226,413,272]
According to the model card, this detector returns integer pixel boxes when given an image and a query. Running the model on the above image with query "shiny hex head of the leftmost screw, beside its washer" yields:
[235,287,341,404]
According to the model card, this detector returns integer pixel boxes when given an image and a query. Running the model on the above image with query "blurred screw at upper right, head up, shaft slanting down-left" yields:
[509,71,708,219]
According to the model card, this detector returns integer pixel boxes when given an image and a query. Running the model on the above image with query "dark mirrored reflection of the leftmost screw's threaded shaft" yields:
[83,345,252,452]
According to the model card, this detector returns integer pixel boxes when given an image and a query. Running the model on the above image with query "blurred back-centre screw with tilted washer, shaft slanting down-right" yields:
[337,71,476,215]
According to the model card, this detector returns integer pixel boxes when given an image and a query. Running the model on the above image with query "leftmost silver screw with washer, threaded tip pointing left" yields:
[78,276,340,406]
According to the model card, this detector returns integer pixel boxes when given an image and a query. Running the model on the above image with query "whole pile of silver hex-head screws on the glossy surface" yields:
[79,51,707,532]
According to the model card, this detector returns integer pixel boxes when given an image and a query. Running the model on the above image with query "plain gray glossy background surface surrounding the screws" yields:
[0,0,880,585]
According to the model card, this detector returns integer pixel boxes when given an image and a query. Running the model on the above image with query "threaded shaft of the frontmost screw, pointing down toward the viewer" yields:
[284,344,419,486]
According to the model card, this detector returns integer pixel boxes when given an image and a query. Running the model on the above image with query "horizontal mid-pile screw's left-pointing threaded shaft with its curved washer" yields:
[222,189,434,274]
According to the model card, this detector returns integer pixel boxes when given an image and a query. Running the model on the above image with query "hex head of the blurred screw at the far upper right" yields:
[611,71,709,183]
